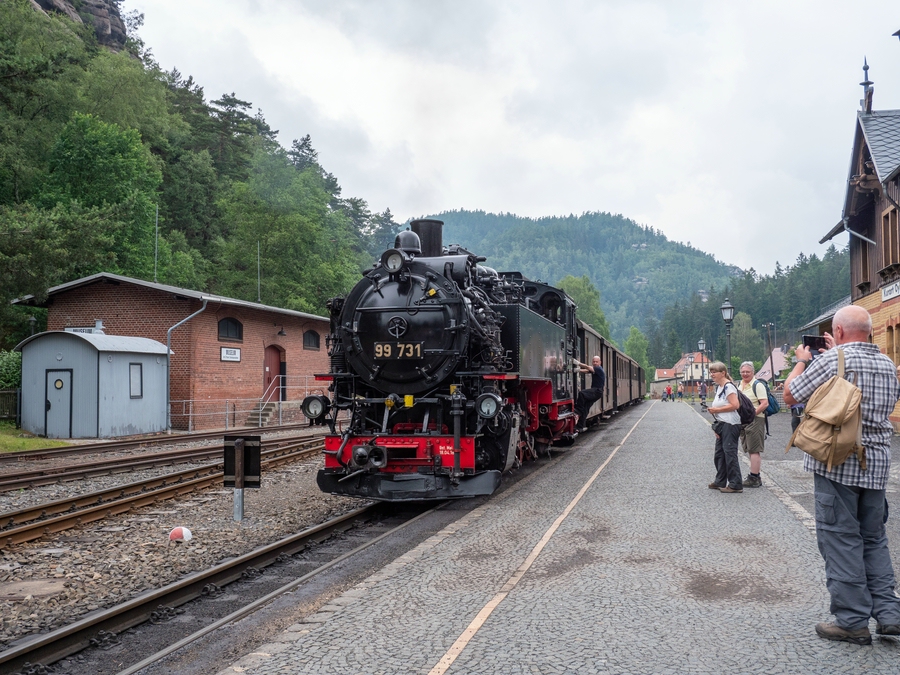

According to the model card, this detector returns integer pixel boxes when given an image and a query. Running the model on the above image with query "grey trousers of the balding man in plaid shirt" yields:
[815,474,900,630]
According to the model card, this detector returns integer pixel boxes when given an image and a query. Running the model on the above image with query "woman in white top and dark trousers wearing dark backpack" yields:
[707,361,744,493]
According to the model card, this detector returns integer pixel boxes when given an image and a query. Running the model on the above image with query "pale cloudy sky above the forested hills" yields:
[122,0,900,274]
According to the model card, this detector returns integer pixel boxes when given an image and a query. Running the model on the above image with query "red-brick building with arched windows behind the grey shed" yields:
[16,273,329,429]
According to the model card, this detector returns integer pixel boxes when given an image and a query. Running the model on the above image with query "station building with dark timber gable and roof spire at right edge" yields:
[820,65,900,429]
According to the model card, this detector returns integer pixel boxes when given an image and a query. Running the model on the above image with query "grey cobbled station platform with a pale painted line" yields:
[213,401,900,675]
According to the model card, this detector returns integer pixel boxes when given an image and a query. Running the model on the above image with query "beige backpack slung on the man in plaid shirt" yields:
[785,348,866,471]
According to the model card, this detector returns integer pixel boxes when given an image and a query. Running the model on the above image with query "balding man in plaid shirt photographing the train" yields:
[784,305,900,645]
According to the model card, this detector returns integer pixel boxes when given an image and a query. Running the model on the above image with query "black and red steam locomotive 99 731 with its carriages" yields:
[302,219,645,501]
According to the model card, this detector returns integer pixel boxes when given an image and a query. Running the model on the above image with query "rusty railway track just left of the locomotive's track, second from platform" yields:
[0,438,324,550]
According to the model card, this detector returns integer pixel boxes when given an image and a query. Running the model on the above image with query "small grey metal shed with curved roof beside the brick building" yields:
[16,331,166,438]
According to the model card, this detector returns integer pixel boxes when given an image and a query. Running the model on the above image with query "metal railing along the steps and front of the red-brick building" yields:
[169,375,328,431]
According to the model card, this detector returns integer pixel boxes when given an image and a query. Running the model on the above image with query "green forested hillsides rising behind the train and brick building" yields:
[0,0,849,366]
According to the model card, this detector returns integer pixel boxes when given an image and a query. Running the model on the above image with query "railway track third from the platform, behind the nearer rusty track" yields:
[0,436,322,492]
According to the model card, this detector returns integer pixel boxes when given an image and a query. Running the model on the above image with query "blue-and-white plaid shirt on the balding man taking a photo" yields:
[790,342,900,490]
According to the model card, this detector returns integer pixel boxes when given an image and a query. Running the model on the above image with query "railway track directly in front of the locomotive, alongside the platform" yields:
[0,505,402,673]
